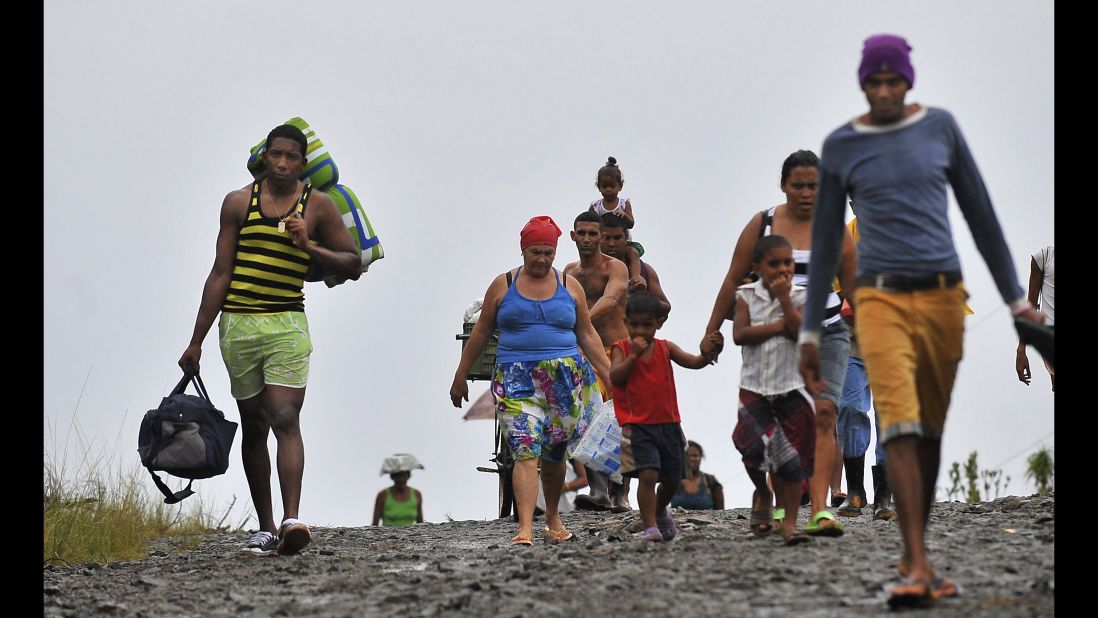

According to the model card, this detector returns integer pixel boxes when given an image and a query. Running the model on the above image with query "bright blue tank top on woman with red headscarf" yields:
[495,268,580,362]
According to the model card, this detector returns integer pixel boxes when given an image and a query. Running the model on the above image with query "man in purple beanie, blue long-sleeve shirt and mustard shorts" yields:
[799,34,1041,607]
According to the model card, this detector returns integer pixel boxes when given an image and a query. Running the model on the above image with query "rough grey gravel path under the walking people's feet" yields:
[43,494,1055,618]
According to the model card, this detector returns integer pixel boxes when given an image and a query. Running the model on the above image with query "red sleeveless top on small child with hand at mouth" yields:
[614,339,682,425]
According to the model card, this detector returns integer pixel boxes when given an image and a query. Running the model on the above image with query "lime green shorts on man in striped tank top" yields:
[217,311,313,400]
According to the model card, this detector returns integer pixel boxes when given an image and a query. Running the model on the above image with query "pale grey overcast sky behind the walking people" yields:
[43,0,1054,526]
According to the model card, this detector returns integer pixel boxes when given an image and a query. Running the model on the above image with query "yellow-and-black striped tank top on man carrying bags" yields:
[221,182,312,313]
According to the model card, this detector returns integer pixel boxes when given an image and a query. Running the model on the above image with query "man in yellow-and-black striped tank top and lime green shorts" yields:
[179,124,361,554]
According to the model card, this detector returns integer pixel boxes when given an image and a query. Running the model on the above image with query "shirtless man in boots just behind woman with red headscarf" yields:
[564,211,630,513]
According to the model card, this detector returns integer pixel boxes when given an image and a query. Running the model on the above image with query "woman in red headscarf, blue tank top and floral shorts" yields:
[450,216,610,546]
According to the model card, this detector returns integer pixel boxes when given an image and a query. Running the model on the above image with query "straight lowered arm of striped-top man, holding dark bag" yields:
[179,190,248,372]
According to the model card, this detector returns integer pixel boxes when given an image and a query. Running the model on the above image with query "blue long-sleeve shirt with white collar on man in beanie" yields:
[802,108,1024,333]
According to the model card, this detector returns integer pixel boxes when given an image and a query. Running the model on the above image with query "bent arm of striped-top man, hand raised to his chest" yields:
[285,191,362,280]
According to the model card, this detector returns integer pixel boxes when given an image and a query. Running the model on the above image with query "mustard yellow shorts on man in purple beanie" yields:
[854,283,968,443]
